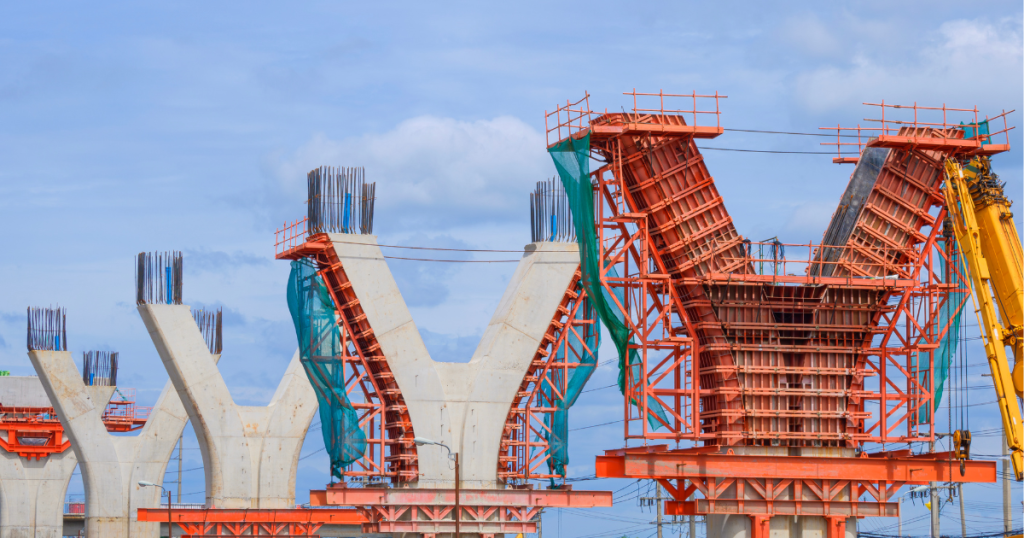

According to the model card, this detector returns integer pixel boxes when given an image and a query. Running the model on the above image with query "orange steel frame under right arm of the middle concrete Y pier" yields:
[498,267,597,479]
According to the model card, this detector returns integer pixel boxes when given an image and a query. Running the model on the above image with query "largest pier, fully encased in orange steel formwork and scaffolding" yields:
[547,91,1006,538]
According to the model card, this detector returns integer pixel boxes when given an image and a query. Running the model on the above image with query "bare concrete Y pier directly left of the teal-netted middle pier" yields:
[138,304,316,508]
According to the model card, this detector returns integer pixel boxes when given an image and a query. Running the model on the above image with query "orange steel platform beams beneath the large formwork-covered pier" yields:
[596,445,996,519]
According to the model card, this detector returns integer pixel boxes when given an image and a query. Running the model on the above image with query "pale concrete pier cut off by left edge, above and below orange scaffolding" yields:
[0,376,78,538]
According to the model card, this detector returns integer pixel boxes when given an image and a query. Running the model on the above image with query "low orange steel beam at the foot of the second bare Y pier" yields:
[138,505,367,538]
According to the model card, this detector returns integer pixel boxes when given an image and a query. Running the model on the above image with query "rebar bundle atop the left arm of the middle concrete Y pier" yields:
[306,166,377,235]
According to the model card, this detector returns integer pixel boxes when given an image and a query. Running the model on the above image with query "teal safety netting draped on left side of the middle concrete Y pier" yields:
[288,260,367,479]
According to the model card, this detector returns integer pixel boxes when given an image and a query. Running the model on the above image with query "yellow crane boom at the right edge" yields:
[944,157,1024,481]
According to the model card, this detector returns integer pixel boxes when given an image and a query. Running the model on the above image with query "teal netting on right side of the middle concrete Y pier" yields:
[541,301,601,482]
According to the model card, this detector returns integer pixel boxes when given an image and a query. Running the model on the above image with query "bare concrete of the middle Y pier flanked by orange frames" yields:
[331,234,580,488]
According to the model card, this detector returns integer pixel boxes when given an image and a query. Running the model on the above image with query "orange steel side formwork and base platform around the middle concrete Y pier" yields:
[274,219,611,536]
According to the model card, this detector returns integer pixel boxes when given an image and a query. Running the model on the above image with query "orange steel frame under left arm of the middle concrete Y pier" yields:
[275,225,419,485]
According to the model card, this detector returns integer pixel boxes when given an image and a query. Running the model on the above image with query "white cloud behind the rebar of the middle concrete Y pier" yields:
[275,116,554,230]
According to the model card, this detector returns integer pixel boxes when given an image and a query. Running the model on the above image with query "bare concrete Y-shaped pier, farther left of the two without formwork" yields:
[29,351,187,538]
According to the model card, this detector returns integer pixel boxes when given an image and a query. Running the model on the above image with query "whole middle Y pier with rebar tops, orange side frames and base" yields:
[276,168,611,536]
